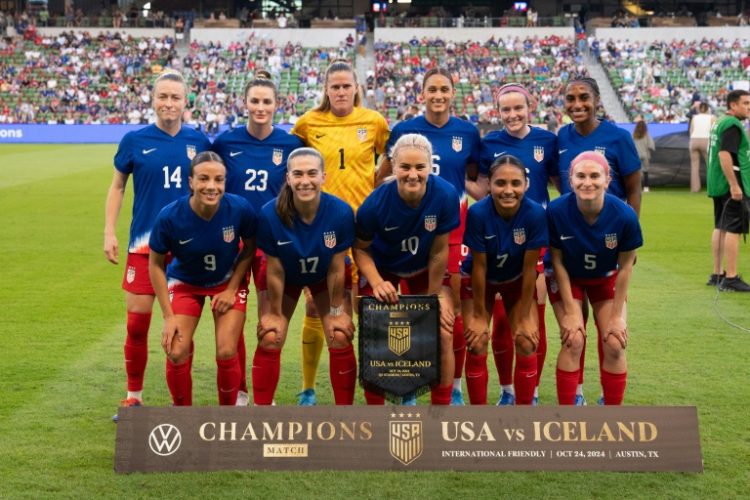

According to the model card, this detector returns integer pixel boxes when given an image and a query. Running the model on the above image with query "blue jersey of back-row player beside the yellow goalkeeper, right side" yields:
[386,116,479,198]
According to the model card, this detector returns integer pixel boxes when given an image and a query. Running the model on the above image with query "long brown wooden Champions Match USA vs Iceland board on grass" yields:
[115,406,703,473]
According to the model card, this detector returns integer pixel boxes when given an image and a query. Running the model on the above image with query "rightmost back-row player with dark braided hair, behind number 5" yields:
[557,76,641,405]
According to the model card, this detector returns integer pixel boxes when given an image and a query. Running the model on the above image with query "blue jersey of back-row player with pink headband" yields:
[479,127,560,207]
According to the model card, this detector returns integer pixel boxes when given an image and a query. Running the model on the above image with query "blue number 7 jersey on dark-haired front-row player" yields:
[463,196,548,283]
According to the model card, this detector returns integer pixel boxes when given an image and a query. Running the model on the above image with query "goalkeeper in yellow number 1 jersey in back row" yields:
[292,61,389,406]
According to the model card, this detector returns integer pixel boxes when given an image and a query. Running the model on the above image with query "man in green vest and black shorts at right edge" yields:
[706,90,750,292]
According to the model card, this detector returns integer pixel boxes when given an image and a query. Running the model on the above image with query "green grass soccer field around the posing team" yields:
[0,145,750,499]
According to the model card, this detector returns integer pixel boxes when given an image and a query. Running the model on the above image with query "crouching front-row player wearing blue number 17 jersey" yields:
[253,148,357,405]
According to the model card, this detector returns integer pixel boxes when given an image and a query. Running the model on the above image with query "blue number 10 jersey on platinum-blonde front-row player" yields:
[357,175,459,276]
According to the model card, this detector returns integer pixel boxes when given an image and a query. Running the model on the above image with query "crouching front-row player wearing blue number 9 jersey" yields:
[149,151,258,406]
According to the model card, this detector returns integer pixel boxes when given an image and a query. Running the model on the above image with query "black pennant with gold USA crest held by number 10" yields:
[359,295,440,402]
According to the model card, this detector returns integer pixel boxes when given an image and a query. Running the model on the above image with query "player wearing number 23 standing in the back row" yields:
[212,77,302,406]
